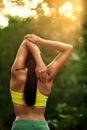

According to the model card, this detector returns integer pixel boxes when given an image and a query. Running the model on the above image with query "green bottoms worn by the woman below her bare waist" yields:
[11,120,50,130]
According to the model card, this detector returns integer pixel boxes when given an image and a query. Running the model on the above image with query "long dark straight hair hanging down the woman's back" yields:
[24,54,37,106]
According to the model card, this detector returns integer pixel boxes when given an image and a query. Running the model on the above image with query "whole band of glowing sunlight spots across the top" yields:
[0,0,83,29]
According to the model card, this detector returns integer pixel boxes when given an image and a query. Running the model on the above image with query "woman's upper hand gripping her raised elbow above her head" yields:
[24,34,42,44]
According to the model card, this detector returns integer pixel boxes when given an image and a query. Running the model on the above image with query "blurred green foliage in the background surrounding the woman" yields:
[0,3,87,130]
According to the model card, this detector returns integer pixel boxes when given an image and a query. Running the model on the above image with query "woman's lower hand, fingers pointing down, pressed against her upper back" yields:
[35,63,47,82]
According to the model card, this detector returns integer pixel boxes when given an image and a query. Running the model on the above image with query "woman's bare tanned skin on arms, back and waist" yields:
[10,34,72,121]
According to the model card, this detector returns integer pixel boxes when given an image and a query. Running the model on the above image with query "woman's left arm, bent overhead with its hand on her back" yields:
[11,39,47,81]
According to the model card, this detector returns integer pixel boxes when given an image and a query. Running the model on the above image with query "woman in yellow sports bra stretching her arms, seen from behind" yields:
[10,34,73,130]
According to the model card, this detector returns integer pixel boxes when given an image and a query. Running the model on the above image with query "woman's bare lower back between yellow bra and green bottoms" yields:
[14,106,45,120]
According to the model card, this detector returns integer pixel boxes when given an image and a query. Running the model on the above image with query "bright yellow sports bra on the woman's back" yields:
[10,87,48,106]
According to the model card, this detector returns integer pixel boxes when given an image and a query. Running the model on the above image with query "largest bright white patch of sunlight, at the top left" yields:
[2,0,43,18]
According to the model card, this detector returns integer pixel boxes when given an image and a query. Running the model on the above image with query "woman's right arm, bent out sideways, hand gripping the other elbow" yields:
[25,34,73,79]
